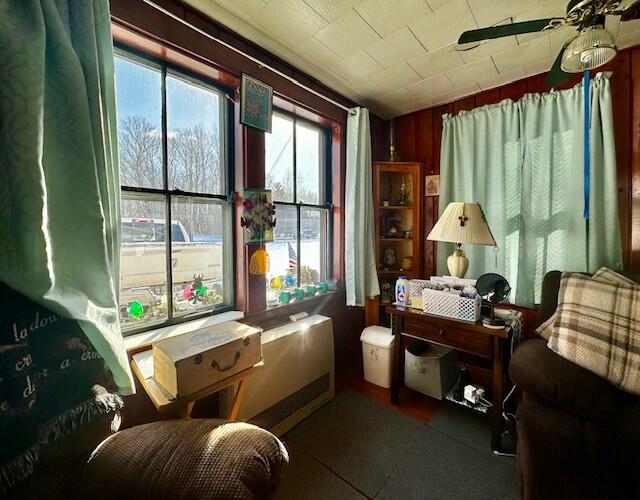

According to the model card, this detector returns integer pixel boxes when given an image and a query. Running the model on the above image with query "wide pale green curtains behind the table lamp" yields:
[438,73,622,306]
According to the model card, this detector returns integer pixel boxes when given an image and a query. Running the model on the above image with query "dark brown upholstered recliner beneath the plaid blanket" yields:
[509,271,640,500]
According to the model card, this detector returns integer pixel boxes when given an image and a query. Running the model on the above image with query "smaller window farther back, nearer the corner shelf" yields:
[265,113,331,305]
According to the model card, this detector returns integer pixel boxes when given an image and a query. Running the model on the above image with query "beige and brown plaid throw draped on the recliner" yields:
[548,270,640,395]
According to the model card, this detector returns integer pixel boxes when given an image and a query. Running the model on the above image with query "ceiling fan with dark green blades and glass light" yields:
[458,0,640,87]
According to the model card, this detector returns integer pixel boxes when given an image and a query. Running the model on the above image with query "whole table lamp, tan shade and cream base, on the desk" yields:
[427,201,496,278]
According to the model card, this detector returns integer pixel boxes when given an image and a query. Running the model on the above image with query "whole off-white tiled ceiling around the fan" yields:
[185,0,640,117]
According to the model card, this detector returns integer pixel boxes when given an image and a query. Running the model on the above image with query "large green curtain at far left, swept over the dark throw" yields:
[0,0,134,394]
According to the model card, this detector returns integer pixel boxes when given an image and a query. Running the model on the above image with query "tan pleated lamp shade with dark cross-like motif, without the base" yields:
[427,201,496,246]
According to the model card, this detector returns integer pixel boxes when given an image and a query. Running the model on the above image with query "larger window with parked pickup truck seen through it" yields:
[115,51,233,333]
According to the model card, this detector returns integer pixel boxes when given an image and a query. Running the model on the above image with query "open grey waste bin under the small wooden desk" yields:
[404,341,458,399]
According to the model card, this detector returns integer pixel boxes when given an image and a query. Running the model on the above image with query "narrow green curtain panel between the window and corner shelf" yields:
[344,108,380,306]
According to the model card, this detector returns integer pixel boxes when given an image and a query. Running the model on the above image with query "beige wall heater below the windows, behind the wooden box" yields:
[220,314,335,436]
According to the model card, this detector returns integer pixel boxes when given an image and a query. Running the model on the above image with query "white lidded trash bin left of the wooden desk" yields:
[360,326,394,389]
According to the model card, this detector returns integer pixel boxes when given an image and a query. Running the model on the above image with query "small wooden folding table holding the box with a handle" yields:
[131,349,264,422]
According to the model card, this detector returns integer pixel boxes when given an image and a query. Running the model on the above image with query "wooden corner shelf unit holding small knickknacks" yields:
[366,162,424,326]
